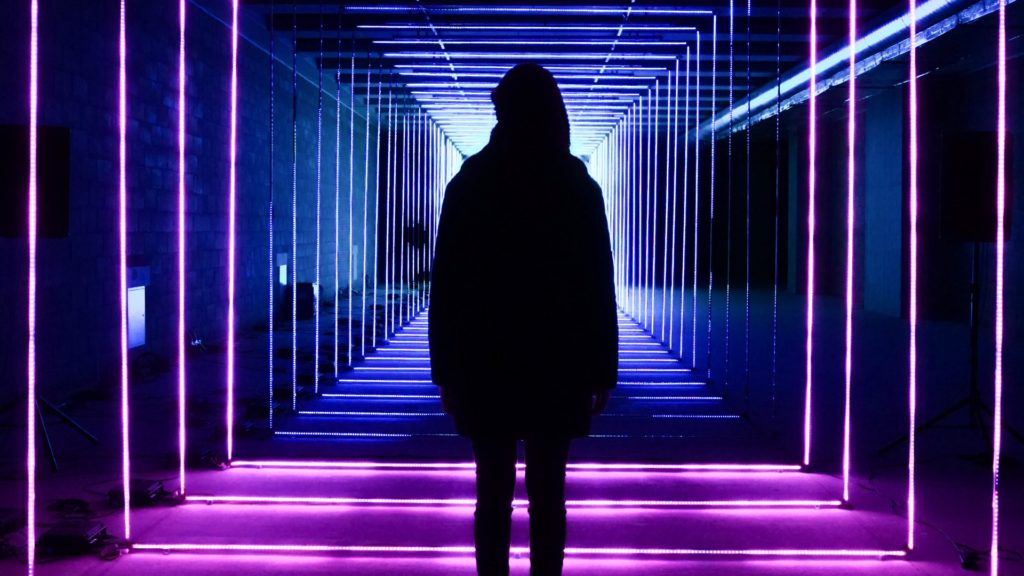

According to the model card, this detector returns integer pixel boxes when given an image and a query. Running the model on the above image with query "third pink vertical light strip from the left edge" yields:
[178,0,186,487]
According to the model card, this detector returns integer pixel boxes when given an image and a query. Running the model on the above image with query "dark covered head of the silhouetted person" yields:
[490,64,569,151]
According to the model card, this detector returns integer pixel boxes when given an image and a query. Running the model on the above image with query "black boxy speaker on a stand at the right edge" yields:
[941,131,1014,242]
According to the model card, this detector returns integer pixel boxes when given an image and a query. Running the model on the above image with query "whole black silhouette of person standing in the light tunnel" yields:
[430,64,618,576]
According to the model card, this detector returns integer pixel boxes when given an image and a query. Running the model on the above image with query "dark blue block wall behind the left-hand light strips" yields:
[0,0,373,399]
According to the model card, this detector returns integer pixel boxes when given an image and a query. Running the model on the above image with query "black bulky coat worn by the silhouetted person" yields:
[430,129,618,439]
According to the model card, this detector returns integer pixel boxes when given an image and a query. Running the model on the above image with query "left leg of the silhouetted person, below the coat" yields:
[473,438,516,576]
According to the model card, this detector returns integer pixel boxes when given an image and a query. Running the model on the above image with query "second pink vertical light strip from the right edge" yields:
[906,0,918,550]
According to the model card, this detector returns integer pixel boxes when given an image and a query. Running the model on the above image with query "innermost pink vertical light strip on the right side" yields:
[804,0,819,466]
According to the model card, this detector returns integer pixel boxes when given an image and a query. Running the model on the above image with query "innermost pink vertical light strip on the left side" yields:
[226,0,239,462]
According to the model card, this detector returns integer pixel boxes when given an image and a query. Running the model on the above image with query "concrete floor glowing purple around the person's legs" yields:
[0,294,1024,576]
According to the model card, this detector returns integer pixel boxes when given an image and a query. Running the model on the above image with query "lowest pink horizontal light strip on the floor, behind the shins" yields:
[132,543,906,560]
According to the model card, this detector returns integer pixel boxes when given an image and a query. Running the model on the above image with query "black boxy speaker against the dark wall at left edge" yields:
[0,124,71,238]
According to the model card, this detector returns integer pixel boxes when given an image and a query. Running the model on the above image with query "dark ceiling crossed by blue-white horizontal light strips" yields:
[244,0,921,152]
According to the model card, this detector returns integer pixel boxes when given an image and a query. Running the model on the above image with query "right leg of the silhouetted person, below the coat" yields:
[526,439,569,576]
